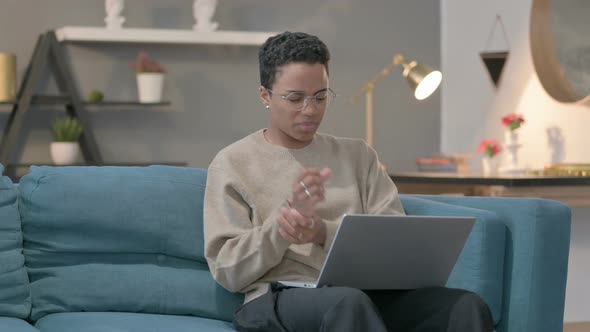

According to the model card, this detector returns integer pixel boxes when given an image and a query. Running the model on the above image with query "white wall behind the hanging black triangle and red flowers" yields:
[441,0,590,321]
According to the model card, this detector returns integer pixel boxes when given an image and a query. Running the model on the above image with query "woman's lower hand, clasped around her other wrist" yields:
[277,207,326,245]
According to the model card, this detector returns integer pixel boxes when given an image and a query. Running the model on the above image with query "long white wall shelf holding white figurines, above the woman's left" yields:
[55,26,277,46]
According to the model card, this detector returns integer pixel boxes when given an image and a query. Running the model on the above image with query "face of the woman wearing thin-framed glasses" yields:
[259,63,329,149]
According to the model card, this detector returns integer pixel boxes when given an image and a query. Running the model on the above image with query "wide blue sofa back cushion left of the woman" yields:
[19,166,243,321]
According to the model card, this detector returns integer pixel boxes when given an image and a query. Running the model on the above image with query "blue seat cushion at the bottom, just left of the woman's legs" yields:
[36,312,235,332]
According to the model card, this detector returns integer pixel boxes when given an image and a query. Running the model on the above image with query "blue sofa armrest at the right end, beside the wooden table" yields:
[404,195,571,332]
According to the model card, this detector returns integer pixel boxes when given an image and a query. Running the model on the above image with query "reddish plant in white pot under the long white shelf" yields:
[131,52,164,103]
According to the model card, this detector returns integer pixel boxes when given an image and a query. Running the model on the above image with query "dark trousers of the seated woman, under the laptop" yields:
[234,284,494,332]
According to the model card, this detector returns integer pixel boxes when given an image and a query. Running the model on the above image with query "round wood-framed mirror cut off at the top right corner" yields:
[530,0,590,105]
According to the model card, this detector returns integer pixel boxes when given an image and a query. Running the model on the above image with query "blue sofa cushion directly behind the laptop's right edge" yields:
[401,195,506,323]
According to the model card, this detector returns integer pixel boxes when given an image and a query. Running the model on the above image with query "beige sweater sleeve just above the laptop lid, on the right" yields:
[365,145,405,215]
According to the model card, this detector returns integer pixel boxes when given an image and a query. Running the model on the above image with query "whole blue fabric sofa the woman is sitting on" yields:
[0,166,571,332]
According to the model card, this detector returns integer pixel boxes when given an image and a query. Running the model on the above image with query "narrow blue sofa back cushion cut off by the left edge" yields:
[0,165,31,320]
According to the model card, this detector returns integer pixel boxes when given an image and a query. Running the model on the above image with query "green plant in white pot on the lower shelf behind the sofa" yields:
[50,116,82,165]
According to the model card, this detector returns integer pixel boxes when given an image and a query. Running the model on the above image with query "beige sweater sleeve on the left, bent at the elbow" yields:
[203,167,289,292]
